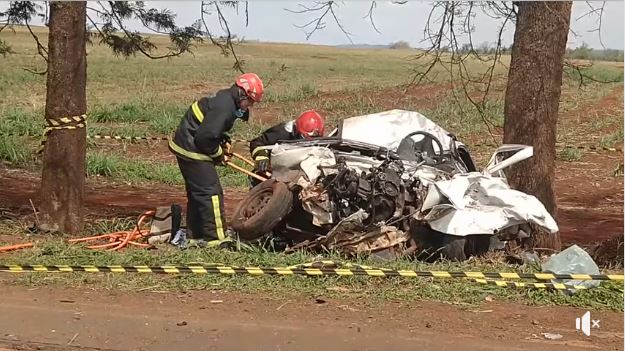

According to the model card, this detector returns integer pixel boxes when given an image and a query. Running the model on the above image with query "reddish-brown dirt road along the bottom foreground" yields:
[0,285,623,351]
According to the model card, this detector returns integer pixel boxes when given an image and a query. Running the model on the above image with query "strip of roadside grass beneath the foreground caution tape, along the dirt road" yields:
[0,239,623,311]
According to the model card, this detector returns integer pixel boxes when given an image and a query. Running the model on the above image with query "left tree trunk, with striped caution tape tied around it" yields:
[40,1,87,233]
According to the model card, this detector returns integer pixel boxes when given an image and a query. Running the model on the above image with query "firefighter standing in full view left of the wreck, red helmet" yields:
[169,73,263,248]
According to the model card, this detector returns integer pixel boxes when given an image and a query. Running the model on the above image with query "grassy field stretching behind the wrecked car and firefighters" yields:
[0,28,623,186]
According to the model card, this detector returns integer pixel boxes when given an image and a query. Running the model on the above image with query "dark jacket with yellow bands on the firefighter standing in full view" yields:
[169,86,249,161]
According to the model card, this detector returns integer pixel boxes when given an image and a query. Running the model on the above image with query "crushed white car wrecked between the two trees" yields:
[232,110,558,260]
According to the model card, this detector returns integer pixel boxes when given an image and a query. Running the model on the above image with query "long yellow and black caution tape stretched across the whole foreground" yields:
[0,265,623,281]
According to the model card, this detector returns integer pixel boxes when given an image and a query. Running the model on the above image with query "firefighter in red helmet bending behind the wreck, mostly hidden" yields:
[249,110,325,186]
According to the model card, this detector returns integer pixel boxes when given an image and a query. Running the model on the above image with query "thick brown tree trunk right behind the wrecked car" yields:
[504,1,571,250]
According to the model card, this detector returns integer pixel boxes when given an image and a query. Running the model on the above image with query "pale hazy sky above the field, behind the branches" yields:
[140,0,625,49]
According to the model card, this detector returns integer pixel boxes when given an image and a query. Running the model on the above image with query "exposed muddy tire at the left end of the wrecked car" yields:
[232,179,293,240]
